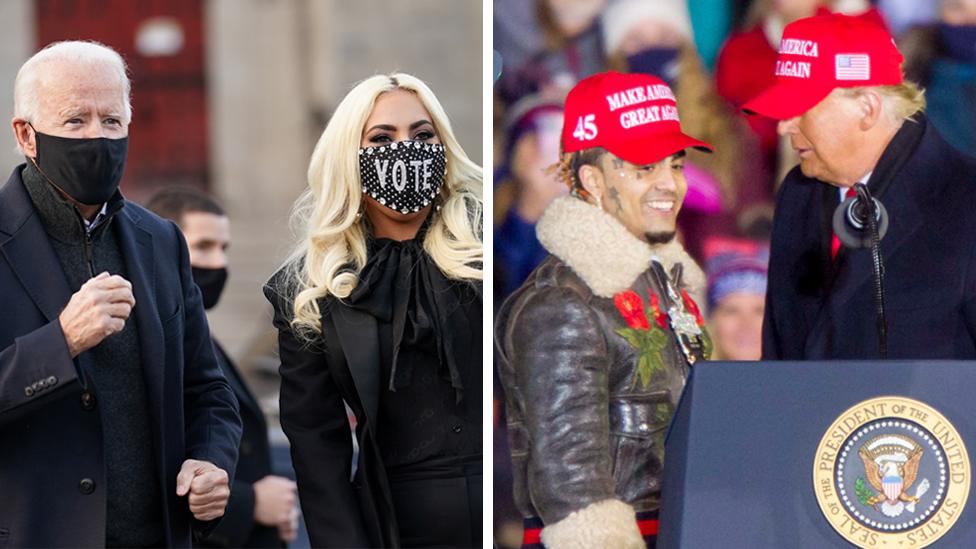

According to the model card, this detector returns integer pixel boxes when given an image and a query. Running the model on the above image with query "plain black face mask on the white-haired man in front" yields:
[31,126,129,206]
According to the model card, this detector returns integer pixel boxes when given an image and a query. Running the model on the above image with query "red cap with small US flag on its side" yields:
[742,14,904,120]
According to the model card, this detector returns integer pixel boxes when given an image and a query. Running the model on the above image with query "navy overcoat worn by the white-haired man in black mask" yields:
[0,166,241,547]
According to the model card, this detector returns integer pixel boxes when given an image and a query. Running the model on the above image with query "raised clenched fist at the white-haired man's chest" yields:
[58,272,136,358]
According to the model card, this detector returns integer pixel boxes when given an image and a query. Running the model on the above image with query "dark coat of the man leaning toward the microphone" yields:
[763,116,976,360]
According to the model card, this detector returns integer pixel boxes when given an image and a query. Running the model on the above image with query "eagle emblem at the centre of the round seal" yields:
[855,434,929,517]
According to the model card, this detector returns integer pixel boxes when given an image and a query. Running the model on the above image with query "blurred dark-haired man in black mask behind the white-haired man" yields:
[146,187,298,547]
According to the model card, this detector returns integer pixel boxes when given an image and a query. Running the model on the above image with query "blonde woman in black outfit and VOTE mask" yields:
[265,74,483,547]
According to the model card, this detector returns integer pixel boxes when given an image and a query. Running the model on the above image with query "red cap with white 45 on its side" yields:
[562,71,712,164]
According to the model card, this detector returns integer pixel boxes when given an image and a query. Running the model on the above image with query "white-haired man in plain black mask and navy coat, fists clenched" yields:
[0,42,241,547]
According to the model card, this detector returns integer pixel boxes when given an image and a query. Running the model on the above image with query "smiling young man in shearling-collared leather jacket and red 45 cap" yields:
[496,72,711,548]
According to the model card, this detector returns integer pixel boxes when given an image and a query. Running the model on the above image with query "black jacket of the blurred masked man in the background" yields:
[199,340,284,547]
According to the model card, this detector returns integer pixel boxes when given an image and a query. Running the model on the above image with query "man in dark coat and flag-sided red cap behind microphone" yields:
[743,14,976,360]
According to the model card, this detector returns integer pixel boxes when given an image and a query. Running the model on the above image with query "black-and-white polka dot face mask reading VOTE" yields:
[359,141,447,214]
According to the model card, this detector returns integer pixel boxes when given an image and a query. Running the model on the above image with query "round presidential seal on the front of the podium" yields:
[813,396,970,547]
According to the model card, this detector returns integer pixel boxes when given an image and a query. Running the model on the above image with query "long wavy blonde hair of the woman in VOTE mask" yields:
[275,73,484,339]
